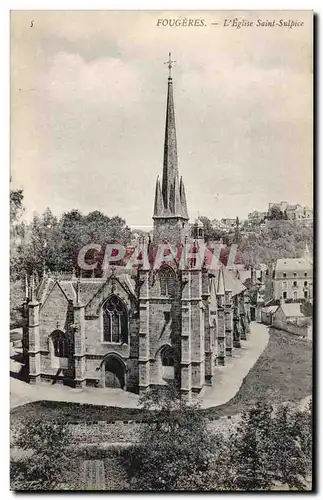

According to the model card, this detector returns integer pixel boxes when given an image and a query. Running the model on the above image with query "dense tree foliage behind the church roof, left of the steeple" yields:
[11,198,131,279]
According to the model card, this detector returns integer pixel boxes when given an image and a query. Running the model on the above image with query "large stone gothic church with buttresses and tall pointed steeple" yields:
[23,61,250,400]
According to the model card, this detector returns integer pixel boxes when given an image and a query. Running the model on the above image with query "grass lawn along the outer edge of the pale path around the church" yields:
[11,329,312,424]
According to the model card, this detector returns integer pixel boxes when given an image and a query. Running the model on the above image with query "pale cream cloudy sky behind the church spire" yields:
[11,11,313,227]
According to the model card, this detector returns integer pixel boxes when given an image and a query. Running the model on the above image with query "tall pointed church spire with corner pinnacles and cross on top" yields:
[153,53,189,220]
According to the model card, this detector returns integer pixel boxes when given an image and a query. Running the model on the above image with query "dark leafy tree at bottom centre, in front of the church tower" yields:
[128,386,219,491]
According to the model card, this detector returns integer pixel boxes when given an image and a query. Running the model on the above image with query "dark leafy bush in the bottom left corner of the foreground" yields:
[10,419,69,491]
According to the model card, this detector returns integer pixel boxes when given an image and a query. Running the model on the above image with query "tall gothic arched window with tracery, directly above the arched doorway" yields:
[103,295,128,343]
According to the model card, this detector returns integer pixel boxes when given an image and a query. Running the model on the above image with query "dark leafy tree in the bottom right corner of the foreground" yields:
[232,403,312,491]
